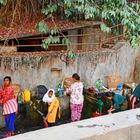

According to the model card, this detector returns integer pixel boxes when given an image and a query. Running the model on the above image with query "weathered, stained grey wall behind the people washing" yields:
[0,42,139,90]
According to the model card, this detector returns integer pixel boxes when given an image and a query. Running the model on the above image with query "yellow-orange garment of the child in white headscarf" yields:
[47,97,60,123]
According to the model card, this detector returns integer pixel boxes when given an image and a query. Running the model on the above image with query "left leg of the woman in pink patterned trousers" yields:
[70,104,77,121]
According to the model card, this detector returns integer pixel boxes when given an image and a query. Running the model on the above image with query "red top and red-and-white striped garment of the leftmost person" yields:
[0,86,18,115]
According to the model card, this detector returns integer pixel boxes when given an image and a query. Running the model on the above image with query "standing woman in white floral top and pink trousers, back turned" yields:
[67,73,84,121]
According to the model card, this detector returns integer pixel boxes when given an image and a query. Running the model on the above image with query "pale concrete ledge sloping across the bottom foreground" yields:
[4,109,140,140]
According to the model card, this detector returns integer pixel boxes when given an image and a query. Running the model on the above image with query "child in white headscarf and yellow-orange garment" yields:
[43,89,60,127]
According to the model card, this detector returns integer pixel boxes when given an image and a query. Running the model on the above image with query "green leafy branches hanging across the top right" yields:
[37,0,140,47]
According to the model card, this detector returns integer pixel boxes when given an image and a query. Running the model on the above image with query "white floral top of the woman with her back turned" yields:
[67,82,84,105]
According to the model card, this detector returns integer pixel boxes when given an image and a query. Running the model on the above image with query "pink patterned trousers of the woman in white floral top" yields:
[70,104,83,121]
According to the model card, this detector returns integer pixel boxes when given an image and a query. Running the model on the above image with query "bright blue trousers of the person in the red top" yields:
[5,113,16,131]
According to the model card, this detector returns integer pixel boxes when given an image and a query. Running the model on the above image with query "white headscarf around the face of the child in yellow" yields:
[42,89,55,104]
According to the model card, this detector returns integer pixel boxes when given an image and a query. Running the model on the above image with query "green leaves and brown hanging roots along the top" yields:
[0,0,140,48]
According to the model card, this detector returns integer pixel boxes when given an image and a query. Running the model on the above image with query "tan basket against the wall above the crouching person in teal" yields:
[106,75,121,89]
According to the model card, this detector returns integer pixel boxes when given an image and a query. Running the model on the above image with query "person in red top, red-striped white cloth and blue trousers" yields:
[0,76,18,137]
